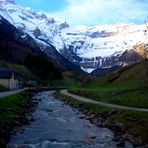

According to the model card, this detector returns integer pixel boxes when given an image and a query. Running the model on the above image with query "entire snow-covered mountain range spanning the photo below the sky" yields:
[0,0,148,71]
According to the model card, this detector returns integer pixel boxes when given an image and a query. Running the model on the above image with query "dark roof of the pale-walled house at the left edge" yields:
[0,68,13,79]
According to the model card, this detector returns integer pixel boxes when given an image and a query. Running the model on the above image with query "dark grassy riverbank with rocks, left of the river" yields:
[0,91,37,148]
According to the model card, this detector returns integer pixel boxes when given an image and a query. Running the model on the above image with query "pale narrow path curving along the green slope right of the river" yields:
[60,89,148,112]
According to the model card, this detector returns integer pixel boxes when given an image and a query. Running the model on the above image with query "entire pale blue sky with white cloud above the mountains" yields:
[16,0,148,26]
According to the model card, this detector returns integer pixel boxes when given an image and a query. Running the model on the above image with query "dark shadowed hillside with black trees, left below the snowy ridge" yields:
[0,13,80,79]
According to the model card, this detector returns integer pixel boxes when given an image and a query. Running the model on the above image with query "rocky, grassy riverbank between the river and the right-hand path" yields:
[55,92,148,147]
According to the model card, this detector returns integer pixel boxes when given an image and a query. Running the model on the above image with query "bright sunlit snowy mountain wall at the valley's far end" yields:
[55,23,148,73]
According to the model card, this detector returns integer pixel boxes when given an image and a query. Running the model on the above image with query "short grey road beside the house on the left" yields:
[0,88,27,99]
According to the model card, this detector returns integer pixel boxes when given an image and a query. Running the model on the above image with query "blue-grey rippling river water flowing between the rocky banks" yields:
[8,92,132,148]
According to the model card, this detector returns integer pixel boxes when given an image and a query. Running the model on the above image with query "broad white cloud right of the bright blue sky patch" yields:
[46,0,148,25]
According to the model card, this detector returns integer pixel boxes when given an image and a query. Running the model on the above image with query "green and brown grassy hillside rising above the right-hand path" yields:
[70,60,148,108]
